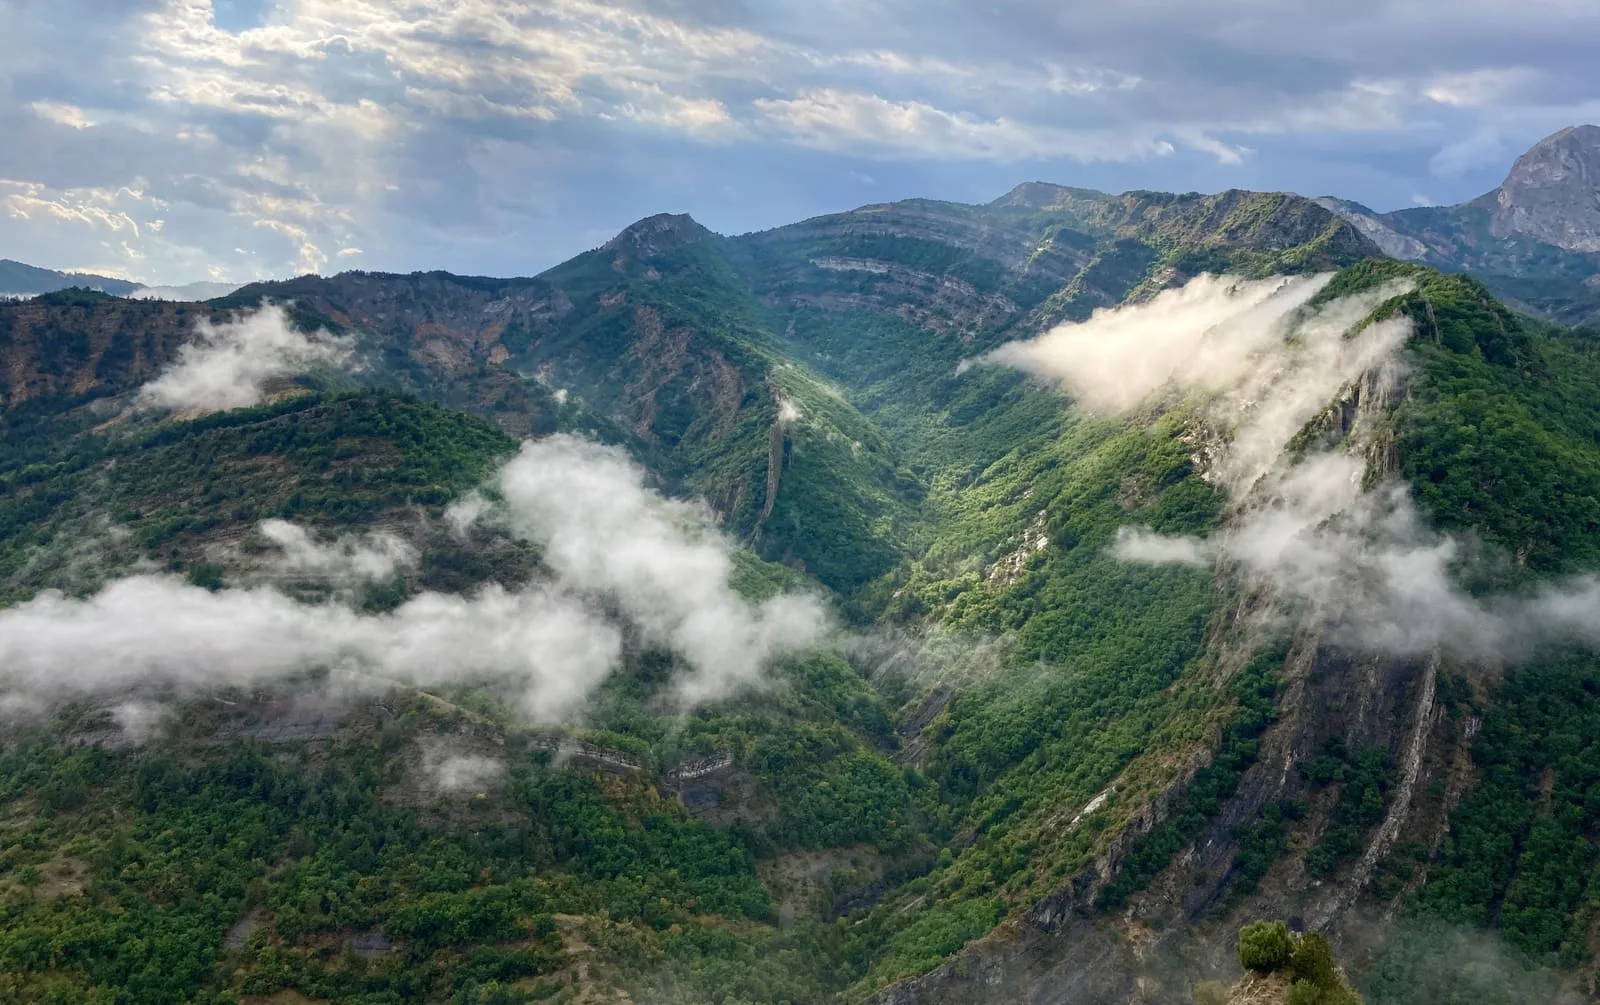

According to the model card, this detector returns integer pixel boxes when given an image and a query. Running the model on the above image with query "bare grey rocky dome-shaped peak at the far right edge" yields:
[1490,125,1600,251]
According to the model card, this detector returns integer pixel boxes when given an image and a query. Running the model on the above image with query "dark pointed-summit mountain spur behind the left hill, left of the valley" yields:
[226,218,922,591]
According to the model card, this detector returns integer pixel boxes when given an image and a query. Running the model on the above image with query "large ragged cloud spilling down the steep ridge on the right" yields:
[986,270,1600,659]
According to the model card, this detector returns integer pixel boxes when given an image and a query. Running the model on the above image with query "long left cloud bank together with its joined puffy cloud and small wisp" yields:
[0,437,829,722]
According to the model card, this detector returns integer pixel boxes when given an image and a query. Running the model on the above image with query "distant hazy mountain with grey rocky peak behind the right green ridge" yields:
[1317,125,1600,325]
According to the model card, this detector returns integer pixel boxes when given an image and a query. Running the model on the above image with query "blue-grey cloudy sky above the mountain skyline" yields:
[0,0,1600,283]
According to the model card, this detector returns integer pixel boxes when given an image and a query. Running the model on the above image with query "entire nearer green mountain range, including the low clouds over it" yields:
[0,182,1600,1005]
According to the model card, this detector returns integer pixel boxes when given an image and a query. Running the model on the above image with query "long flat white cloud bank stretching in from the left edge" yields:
[0,576,622,720]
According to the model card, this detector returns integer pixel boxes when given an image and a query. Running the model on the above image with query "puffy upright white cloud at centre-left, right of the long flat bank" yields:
[466,434,829,704]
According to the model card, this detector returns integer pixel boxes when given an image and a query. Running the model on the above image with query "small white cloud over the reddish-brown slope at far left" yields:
[139,304,350,411]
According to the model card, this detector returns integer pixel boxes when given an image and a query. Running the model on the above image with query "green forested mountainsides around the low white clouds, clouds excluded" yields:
[0,184,1600,1005]
